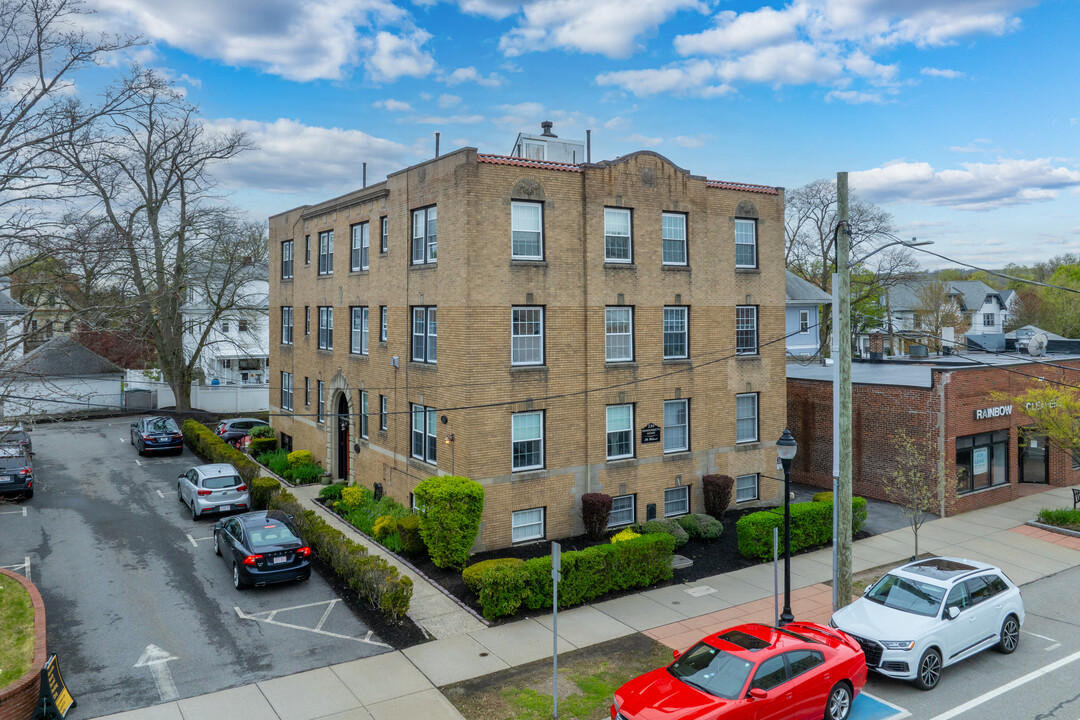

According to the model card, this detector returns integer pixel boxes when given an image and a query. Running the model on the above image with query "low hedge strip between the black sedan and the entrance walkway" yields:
[270,490,413,621]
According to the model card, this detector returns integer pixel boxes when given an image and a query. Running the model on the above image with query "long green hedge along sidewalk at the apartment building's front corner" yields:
[477,532,675,620]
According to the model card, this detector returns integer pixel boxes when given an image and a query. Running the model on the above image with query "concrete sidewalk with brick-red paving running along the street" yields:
[92,488,1080,720]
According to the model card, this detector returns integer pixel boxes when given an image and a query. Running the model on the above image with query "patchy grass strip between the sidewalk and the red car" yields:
[440,633,672,720]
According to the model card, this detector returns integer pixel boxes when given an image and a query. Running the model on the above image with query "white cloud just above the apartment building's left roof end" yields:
[205,118,410,196]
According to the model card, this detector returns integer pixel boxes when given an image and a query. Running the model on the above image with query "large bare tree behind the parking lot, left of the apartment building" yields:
[56,83,254,410]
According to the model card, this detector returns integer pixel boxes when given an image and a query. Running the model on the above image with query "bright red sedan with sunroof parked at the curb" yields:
[611,623,866,720]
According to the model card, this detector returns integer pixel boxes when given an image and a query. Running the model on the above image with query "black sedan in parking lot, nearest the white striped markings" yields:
[214,511,311,590]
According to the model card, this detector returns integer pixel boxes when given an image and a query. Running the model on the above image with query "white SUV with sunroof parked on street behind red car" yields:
[828,557,1024,690]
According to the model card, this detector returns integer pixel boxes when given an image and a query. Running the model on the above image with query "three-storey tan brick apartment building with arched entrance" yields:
[270,136,786,549]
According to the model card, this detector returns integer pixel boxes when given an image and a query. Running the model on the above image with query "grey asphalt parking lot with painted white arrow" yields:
[0,418,391,719]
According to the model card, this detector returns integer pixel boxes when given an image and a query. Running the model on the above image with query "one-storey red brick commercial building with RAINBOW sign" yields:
[787,352,1080,515]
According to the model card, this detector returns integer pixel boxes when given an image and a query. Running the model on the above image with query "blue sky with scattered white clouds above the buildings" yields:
[78,0,1080,267]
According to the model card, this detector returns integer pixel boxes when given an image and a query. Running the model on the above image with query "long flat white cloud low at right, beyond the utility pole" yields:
[851,158,1080,210]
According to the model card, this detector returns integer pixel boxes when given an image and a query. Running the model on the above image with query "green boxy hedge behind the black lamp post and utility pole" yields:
[735,498,866,560]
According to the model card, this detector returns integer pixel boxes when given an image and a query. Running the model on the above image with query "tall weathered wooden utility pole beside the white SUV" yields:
[833,173,851,609]
